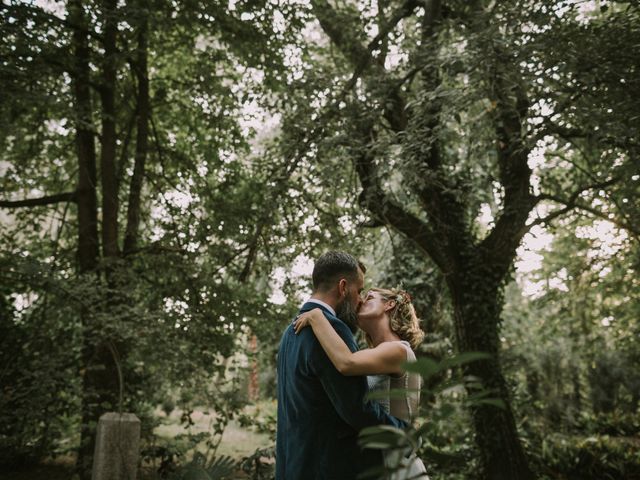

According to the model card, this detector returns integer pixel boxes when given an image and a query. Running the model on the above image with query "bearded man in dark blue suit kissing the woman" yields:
[276,252,406,480]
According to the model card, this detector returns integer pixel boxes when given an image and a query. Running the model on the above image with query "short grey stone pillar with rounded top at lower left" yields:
[91,412,140,480]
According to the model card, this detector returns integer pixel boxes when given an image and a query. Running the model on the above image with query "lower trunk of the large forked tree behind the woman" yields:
[449,265,534,480]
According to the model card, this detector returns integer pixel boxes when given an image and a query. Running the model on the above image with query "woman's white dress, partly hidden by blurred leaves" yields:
[367,340,429,480]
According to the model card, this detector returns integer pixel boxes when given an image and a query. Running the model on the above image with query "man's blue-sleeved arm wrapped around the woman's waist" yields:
[307,319,407,431]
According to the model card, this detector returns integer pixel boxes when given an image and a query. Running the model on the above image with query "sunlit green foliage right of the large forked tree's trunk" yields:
[503,208,638,479]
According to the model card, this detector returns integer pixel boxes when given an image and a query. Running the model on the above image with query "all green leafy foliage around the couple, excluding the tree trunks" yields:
[0,0,640,479]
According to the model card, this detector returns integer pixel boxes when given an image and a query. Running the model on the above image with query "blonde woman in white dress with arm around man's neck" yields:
[294,288,428,480]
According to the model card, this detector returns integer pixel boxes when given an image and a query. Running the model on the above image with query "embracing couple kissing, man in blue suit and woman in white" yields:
[276,251,428,480]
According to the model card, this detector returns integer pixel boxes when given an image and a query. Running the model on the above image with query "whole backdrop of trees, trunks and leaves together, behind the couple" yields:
[0,0,640,479]
